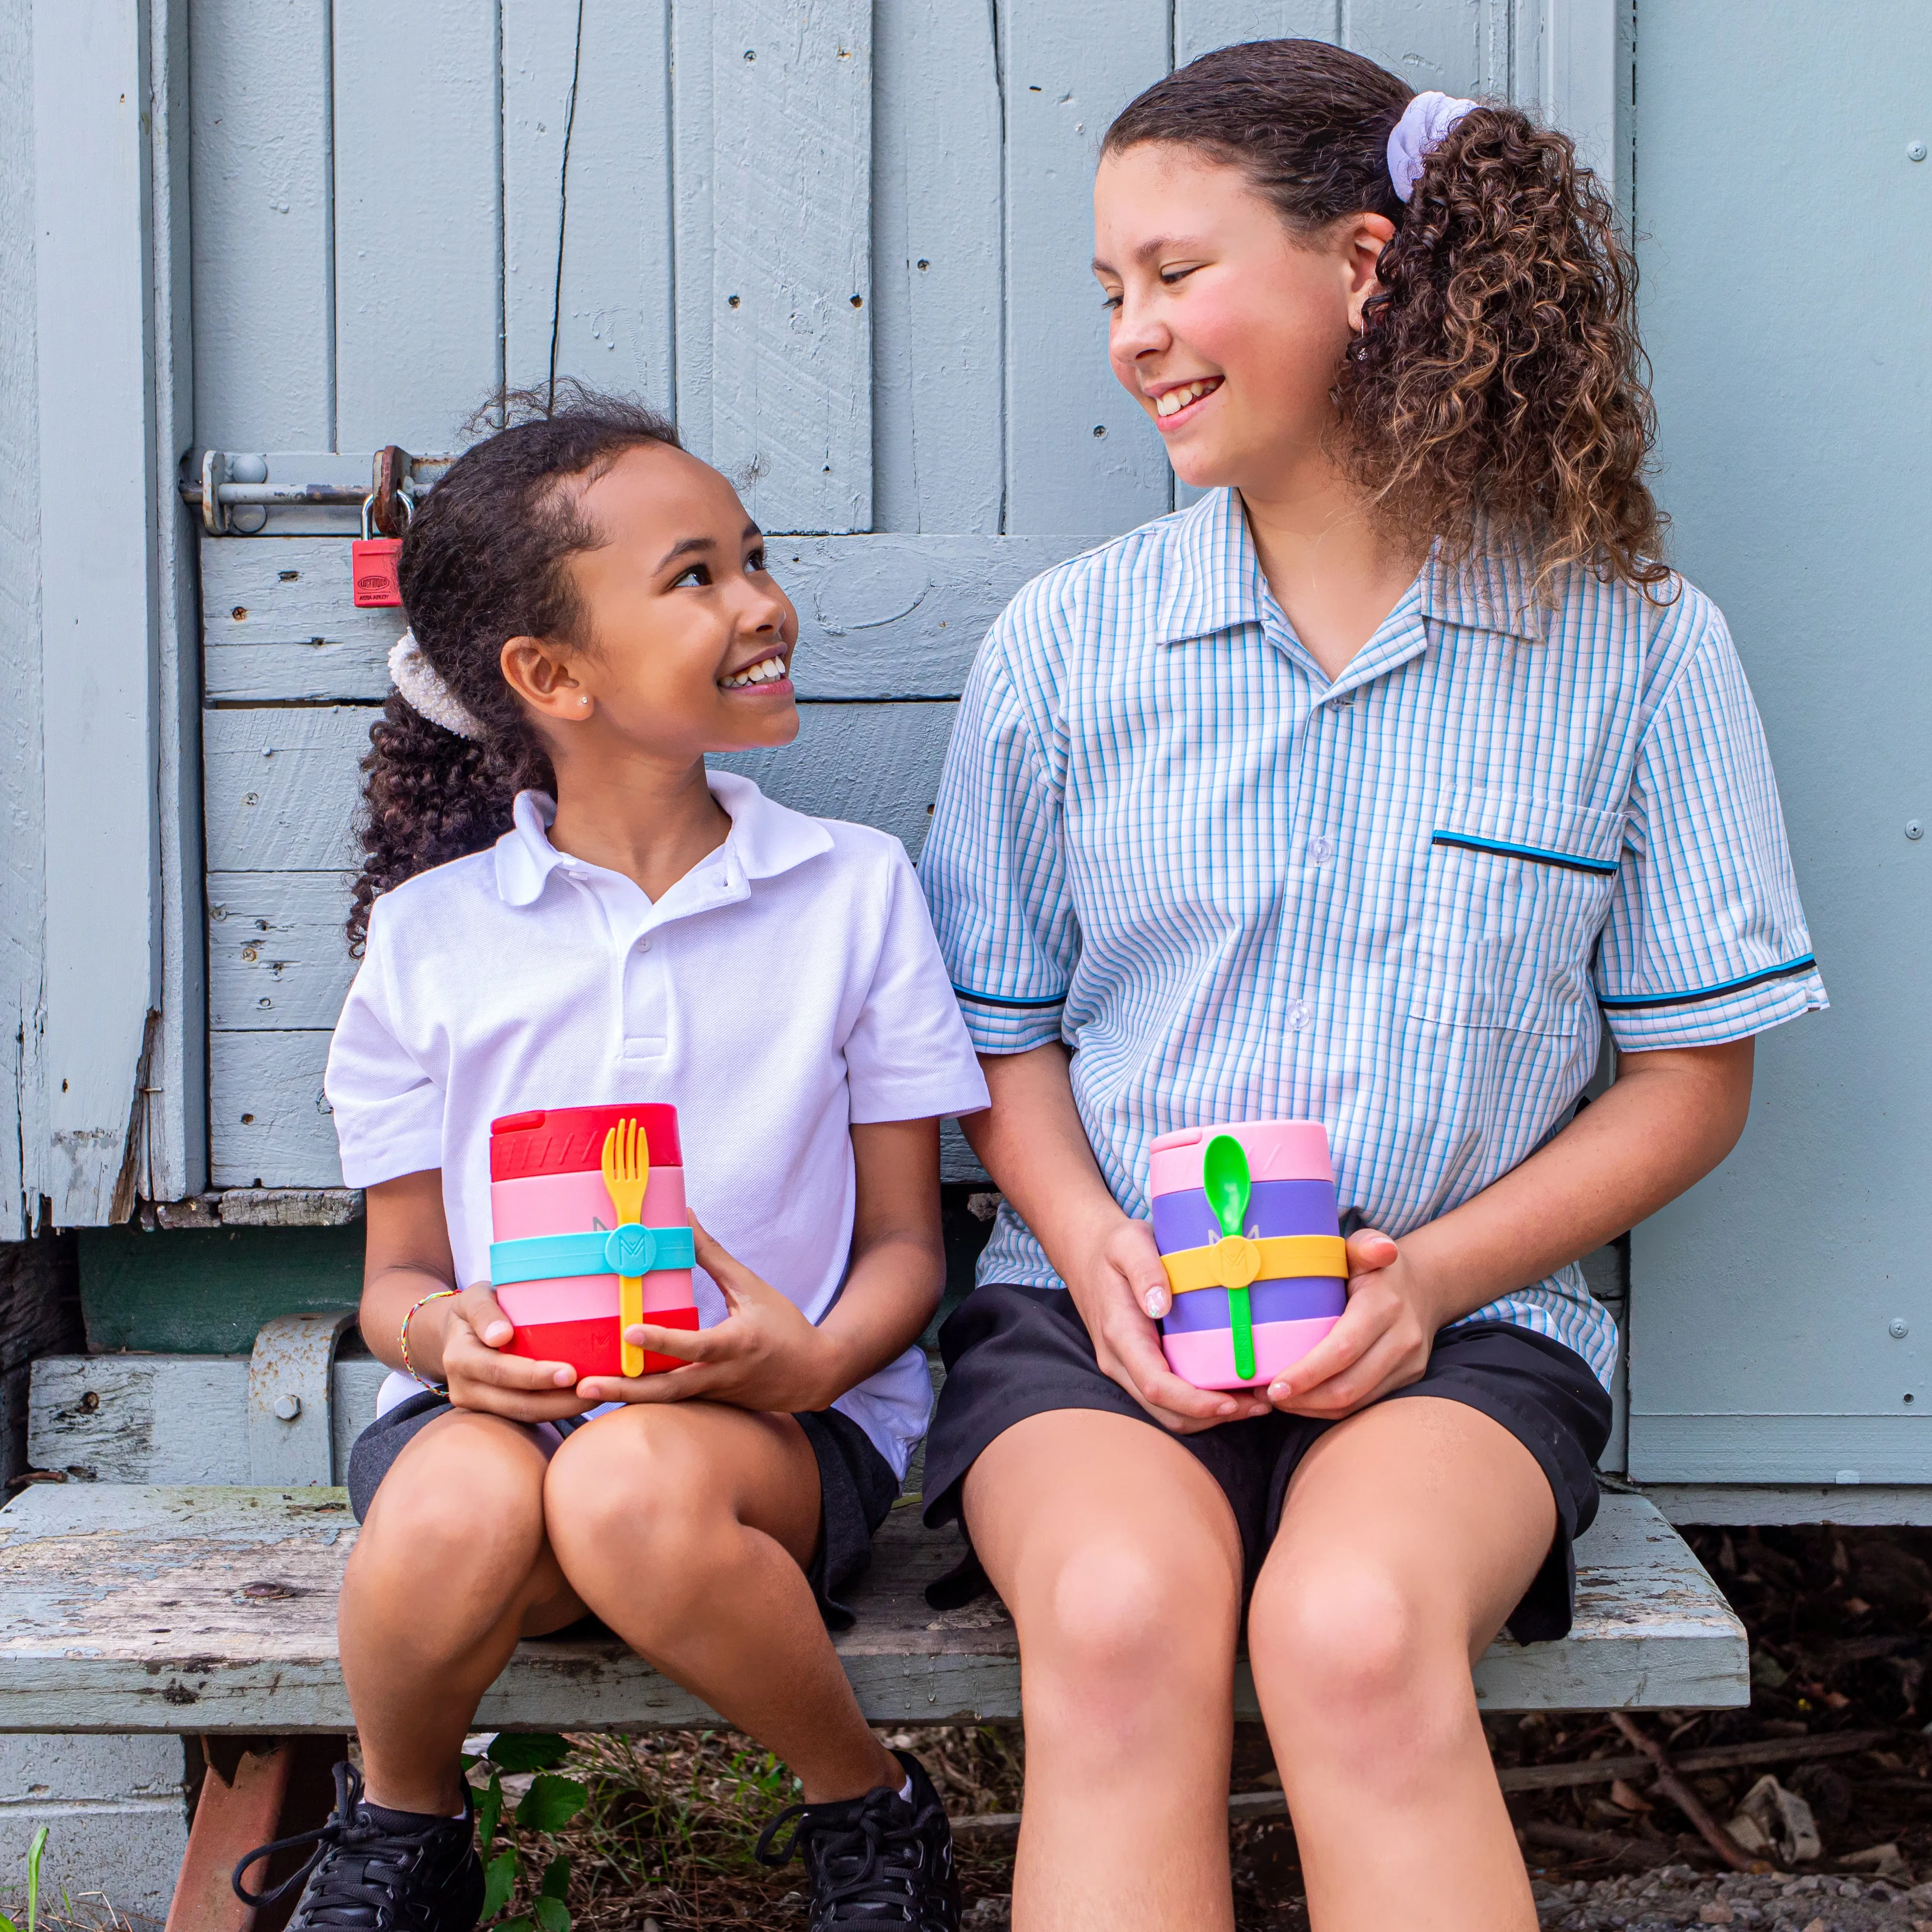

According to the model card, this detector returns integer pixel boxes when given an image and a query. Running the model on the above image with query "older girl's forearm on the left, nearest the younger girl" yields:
[960,1044,1123,1277]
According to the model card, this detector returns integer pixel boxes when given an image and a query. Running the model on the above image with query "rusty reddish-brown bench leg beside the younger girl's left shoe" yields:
[166,1737,350,1932]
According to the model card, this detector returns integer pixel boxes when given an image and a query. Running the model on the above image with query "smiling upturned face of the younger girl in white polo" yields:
[502,444,798,765]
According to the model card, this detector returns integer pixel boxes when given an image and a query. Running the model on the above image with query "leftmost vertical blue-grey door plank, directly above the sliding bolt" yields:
[182,0,336,450]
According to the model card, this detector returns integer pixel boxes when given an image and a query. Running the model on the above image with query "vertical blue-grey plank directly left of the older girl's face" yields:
[1001,0,1173,533]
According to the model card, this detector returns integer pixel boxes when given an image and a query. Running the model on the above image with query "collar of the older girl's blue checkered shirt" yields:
[1150,489,1548,643]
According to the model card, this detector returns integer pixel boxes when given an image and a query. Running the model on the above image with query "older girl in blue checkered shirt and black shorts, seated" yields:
[921,41,1824,1932]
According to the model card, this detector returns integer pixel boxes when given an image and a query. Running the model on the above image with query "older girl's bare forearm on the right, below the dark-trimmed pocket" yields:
[1401,1040,1752,1326]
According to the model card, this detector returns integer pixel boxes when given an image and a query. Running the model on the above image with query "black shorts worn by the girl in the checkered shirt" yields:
[925,1283,1609,1644]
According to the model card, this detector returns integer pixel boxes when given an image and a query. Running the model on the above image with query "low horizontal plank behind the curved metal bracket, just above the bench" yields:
[27,1354,388,1484]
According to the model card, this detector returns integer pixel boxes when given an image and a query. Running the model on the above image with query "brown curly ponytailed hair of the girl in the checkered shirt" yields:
[1103,41,1671,585]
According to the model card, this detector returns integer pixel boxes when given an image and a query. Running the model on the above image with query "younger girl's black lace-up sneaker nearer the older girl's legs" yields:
[757,1750,960,1932]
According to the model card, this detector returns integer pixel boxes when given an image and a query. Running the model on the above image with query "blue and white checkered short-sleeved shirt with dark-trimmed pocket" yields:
[919,491,1826,1383]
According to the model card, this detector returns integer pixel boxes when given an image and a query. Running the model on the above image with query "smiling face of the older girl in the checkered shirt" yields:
[1094,143,1395,496]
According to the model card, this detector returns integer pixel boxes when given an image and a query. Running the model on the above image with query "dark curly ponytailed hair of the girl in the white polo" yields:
[348,382,680,952]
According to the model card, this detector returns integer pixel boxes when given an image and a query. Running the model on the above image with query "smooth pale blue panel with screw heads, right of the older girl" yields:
[1631,0,1932,1484]
